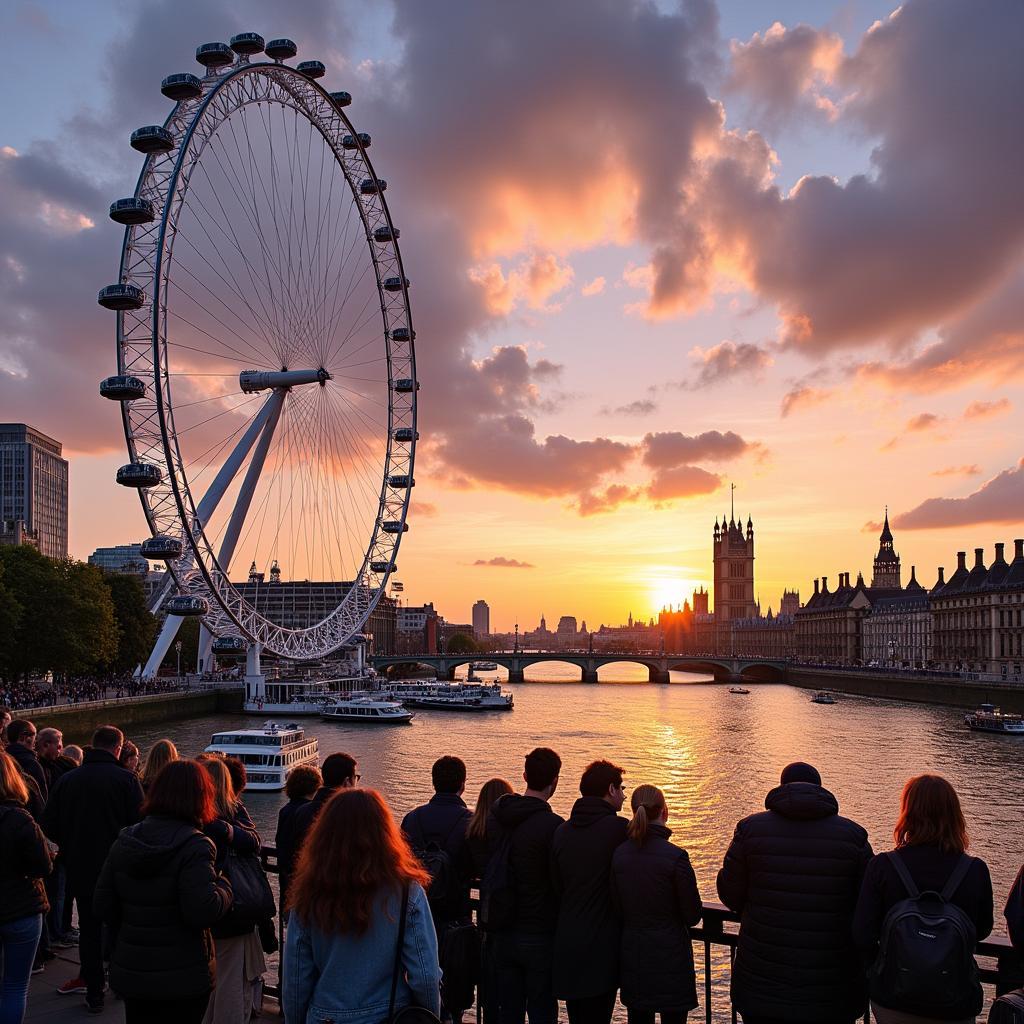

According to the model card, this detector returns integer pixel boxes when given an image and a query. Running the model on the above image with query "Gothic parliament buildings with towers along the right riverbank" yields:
[658,510,1024,679]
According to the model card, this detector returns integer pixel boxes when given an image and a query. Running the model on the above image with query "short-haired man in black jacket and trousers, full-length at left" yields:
[42,725,142,1013]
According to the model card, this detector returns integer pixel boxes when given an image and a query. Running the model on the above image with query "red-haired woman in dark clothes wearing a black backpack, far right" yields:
[853,775,992,1024]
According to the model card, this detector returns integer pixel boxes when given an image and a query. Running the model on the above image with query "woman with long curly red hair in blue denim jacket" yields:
[283,790,440,1024]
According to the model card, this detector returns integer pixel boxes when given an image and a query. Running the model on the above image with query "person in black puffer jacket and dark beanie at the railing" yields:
[718,762,871,1024]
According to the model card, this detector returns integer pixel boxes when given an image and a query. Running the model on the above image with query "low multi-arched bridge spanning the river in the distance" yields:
[371,651,787,683]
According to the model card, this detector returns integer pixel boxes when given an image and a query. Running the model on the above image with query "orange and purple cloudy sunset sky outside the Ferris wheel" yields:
[0,0,1024,629]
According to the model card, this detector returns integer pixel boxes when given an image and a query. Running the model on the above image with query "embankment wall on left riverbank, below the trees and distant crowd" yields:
[17,687,243,744]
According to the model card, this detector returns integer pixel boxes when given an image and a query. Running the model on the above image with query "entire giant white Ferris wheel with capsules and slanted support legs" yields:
[98,33,419,675]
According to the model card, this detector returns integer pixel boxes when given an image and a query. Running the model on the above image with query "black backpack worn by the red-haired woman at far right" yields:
[869,853,981,1017]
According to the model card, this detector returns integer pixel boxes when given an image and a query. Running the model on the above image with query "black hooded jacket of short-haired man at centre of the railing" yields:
[487,793,563,935]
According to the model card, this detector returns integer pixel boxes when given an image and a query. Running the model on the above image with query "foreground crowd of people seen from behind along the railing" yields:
[0,719,1024,1024]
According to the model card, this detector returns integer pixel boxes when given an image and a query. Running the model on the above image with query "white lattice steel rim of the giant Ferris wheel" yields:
[112,54,418,656]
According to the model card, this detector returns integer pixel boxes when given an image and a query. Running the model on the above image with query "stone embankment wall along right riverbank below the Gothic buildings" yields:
[786,666,1024,712]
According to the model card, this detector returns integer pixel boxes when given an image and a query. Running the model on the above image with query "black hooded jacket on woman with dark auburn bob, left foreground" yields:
[93,815,231,999]
